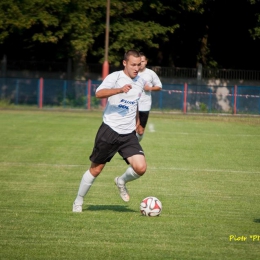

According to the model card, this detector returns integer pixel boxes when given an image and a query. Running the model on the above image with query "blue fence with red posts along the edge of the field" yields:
[0,78,260,114]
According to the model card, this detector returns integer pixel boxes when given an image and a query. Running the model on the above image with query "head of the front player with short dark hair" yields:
[123,50,141,79]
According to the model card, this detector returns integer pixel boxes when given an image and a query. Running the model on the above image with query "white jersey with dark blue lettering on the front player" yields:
[96,70,145,134]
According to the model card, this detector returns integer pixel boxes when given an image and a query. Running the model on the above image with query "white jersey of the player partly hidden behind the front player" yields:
[138,68,162,111]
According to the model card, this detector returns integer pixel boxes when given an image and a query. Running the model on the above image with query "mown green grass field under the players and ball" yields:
[0,110,260,260]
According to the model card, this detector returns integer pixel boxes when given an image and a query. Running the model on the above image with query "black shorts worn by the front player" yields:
[89,122,144,164]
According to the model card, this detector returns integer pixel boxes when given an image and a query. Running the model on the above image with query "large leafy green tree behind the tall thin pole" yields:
[0,0,203,78]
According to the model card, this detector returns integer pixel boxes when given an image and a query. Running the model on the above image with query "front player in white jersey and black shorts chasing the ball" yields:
[72,50,146,212]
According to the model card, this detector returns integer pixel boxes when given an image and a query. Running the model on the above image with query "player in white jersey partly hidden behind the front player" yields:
[136,52,162,142]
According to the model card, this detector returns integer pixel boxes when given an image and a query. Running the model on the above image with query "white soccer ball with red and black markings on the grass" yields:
[140,196,162,217]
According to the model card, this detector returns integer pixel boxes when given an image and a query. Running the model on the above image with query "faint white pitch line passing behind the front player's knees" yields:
[0,162,260,174]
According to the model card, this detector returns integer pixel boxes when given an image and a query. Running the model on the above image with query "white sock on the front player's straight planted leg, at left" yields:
[74,170,96,205]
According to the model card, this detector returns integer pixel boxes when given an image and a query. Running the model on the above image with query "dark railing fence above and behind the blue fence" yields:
[0,56,260,81]
